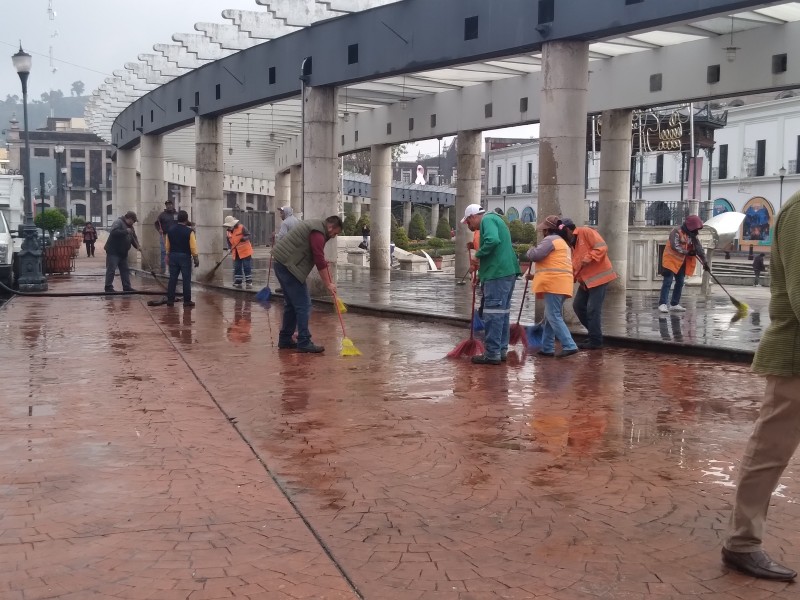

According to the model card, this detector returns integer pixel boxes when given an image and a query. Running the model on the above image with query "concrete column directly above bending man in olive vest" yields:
[303,86,341,220]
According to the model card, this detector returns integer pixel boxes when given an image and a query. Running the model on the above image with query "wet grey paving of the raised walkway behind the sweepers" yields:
[211,248,769,362]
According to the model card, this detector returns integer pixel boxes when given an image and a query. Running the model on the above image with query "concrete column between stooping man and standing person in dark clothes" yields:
[136,135,167,273]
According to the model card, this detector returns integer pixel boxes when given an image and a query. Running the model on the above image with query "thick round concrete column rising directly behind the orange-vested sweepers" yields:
[536,41,588,222]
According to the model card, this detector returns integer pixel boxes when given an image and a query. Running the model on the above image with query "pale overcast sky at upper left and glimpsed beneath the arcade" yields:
[0,0,538,157]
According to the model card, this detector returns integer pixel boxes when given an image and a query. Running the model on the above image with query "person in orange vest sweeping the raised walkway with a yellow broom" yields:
[658,215,709,312]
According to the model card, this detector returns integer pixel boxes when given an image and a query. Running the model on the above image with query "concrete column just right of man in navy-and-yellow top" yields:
[193,117,224,283]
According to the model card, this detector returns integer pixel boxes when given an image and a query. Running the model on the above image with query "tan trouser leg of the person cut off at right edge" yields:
[725,376,800,552]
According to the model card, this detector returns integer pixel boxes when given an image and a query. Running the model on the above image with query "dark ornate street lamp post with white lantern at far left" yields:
[11,44,47,292]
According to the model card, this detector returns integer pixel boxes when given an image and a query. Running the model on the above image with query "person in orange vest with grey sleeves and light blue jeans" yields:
[527,215,578,358]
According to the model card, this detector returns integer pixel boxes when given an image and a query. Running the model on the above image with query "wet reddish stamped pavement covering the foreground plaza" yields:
[0,254,800,600]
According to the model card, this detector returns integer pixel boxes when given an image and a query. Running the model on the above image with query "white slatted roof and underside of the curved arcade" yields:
[86,0,800,179]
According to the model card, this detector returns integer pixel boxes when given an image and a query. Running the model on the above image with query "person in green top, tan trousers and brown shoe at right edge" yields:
[722,192,800,581]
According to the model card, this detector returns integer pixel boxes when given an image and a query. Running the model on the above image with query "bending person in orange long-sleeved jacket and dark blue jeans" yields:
[562,219,617,350]
